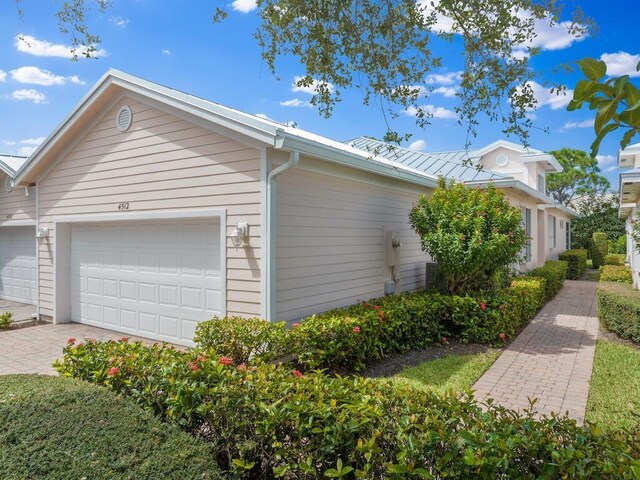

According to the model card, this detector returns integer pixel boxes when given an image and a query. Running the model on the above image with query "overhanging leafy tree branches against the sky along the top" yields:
[15,0,592,144]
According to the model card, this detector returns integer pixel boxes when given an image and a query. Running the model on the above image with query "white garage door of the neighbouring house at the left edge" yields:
[0,227,37,305]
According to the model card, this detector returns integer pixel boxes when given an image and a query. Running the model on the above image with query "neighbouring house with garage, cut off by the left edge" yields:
[0,154,37,305]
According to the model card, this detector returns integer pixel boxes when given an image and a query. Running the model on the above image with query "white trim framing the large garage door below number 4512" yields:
[53,208,228,336]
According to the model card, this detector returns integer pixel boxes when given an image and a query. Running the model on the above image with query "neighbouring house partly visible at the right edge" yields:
[618,143,640,288]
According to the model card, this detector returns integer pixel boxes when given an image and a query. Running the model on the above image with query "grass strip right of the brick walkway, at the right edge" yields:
[587,340,640,430]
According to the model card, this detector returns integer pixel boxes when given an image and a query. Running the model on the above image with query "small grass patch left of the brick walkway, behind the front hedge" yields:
[384,350,501,393]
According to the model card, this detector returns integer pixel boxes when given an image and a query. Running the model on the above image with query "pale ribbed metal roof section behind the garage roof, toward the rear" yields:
[346,137,512,182]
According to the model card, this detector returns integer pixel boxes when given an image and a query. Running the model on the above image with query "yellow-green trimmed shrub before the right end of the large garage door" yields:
[194,317,286,364]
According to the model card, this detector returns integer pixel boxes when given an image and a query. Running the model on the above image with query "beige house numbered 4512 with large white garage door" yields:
[0,70,570,344]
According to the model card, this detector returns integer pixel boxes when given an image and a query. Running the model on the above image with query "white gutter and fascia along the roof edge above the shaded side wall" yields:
[281,132,438,188]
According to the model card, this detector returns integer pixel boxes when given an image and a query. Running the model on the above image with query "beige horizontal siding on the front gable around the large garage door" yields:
[38,98,262,315]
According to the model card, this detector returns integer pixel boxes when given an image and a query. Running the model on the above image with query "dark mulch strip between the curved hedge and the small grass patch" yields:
[363,342,501,378]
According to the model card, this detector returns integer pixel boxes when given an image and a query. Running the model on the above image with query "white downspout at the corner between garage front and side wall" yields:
[265,146,300,322]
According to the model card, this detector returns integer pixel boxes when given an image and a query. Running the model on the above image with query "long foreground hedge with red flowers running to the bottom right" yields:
[57,342,640,480]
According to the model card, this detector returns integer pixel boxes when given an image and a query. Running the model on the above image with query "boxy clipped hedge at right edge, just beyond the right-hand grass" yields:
[596,282,640,343]
